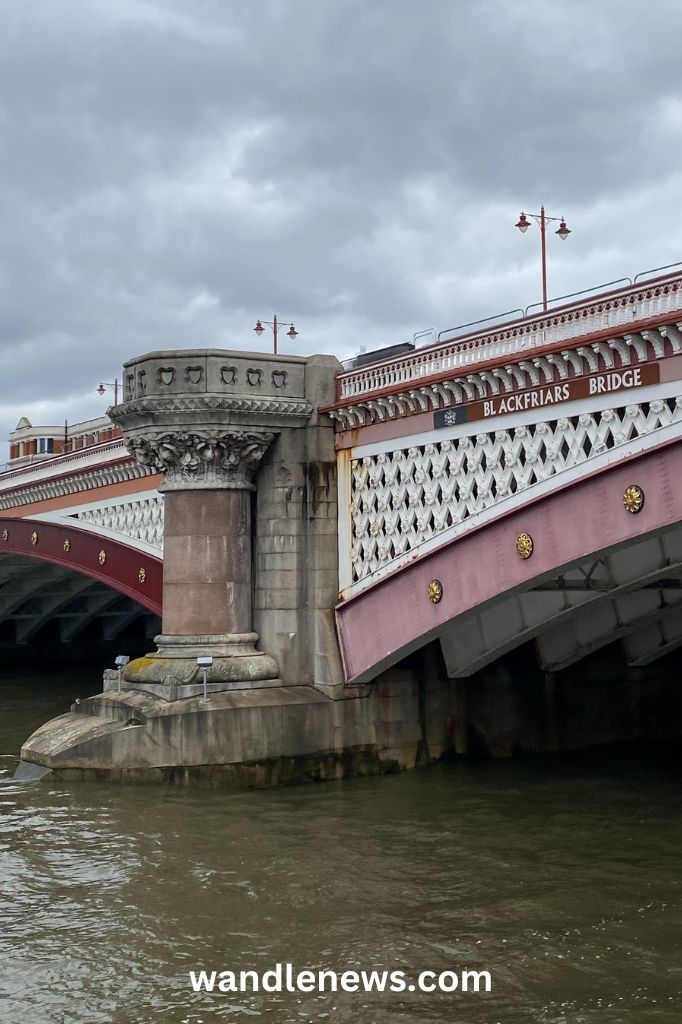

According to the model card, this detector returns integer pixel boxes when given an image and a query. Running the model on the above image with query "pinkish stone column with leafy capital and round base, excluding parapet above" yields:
[112,427,280,699]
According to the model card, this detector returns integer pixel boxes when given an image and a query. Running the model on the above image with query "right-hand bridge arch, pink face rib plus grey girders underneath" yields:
[336,441,682,682]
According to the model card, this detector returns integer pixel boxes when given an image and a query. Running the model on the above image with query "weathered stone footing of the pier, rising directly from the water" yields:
[22,667,420,785]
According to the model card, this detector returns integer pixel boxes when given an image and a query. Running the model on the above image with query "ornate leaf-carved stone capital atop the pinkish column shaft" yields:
[126,430,274,490]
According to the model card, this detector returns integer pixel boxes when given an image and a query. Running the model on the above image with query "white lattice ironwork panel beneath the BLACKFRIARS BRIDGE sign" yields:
[349,397,682,583]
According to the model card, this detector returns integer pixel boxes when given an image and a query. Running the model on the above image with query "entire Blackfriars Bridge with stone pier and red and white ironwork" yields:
[5,273,682,784]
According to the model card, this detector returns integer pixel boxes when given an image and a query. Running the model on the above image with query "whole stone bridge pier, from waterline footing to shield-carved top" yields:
[22,349,409,785]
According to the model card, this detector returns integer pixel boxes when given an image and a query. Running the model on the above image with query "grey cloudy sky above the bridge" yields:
[0,0,682,450]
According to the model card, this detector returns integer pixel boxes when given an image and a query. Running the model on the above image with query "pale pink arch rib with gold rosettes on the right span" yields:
[336,439,682,681]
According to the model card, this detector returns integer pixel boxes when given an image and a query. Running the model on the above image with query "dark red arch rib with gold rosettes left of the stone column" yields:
[0,517,163,615]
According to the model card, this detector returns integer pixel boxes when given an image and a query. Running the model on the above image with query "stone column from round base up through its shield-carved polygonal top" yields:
[109,349,312,699]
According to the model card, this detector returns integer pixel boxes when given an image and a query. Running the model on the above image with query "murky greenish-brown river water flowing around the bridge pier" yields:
[0,673,682,1024]
